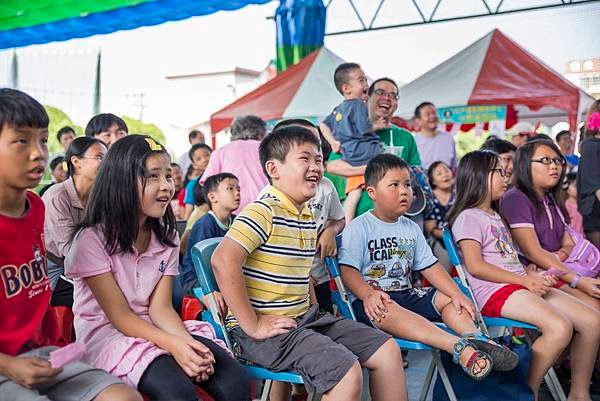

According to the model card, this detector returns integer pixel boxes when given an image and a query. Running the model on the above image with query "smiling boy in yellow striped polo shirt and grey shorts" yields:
[212,126,408,401]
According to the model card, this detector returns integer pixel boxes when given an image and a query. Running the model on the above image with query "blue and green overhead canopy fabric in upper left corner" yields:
[0,0,271,49]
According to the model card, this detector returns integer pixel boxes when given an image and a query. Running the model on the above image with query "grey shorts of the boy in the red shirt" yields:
[0,347,123,401]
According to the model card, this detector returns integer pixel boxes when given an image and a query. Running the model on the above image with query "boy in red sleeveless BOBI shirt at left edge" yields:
[0,89,141,401]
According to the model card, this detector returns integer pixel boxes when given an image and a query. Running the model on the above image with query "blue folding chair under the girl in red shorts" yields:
[442,227,567,401]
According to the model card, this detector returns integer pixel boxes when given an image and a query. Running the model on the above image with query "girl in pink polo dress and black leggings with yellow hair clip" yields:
[65,135,250,401]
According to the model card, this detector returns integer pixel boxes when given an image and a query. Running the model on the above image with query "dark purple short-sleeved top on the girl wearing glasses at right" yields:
[500,187,565,263]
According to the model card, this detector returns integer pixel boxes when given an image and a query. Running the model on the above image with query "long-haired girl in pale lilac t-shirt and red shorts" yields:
[448,151,600,401]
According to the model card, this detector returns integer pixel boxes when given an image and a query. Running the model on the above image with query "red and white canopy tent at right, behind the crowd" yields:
[396,29,594,131]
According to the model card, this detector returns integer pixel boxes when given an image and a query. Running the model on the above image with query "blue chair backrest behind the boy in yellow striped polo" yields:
[192,237,231,349]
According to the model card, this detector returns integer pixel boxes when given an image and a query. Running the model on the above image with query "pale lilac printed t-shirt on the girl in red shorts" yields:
[452,208,526,308]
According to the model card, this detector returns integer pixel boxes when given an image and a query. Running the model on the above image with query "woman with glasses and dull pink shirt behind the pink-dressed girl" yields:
[42,136,108,307]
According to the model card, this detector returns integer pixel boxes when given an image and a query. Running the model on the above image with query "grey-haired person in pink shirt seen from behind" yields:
[200,115,268,214]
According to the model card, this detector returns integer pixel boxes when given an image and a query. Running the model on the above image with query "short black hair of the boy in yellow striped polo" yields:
[258,125,321,183]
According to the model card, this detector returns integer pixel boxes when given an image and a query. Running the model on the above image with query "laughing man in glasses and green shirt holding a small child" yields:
[327,78,421,216]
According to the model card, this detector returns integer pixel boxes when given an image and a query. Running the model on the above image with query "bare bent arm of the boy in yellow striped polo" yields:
[211,237,296,339]
